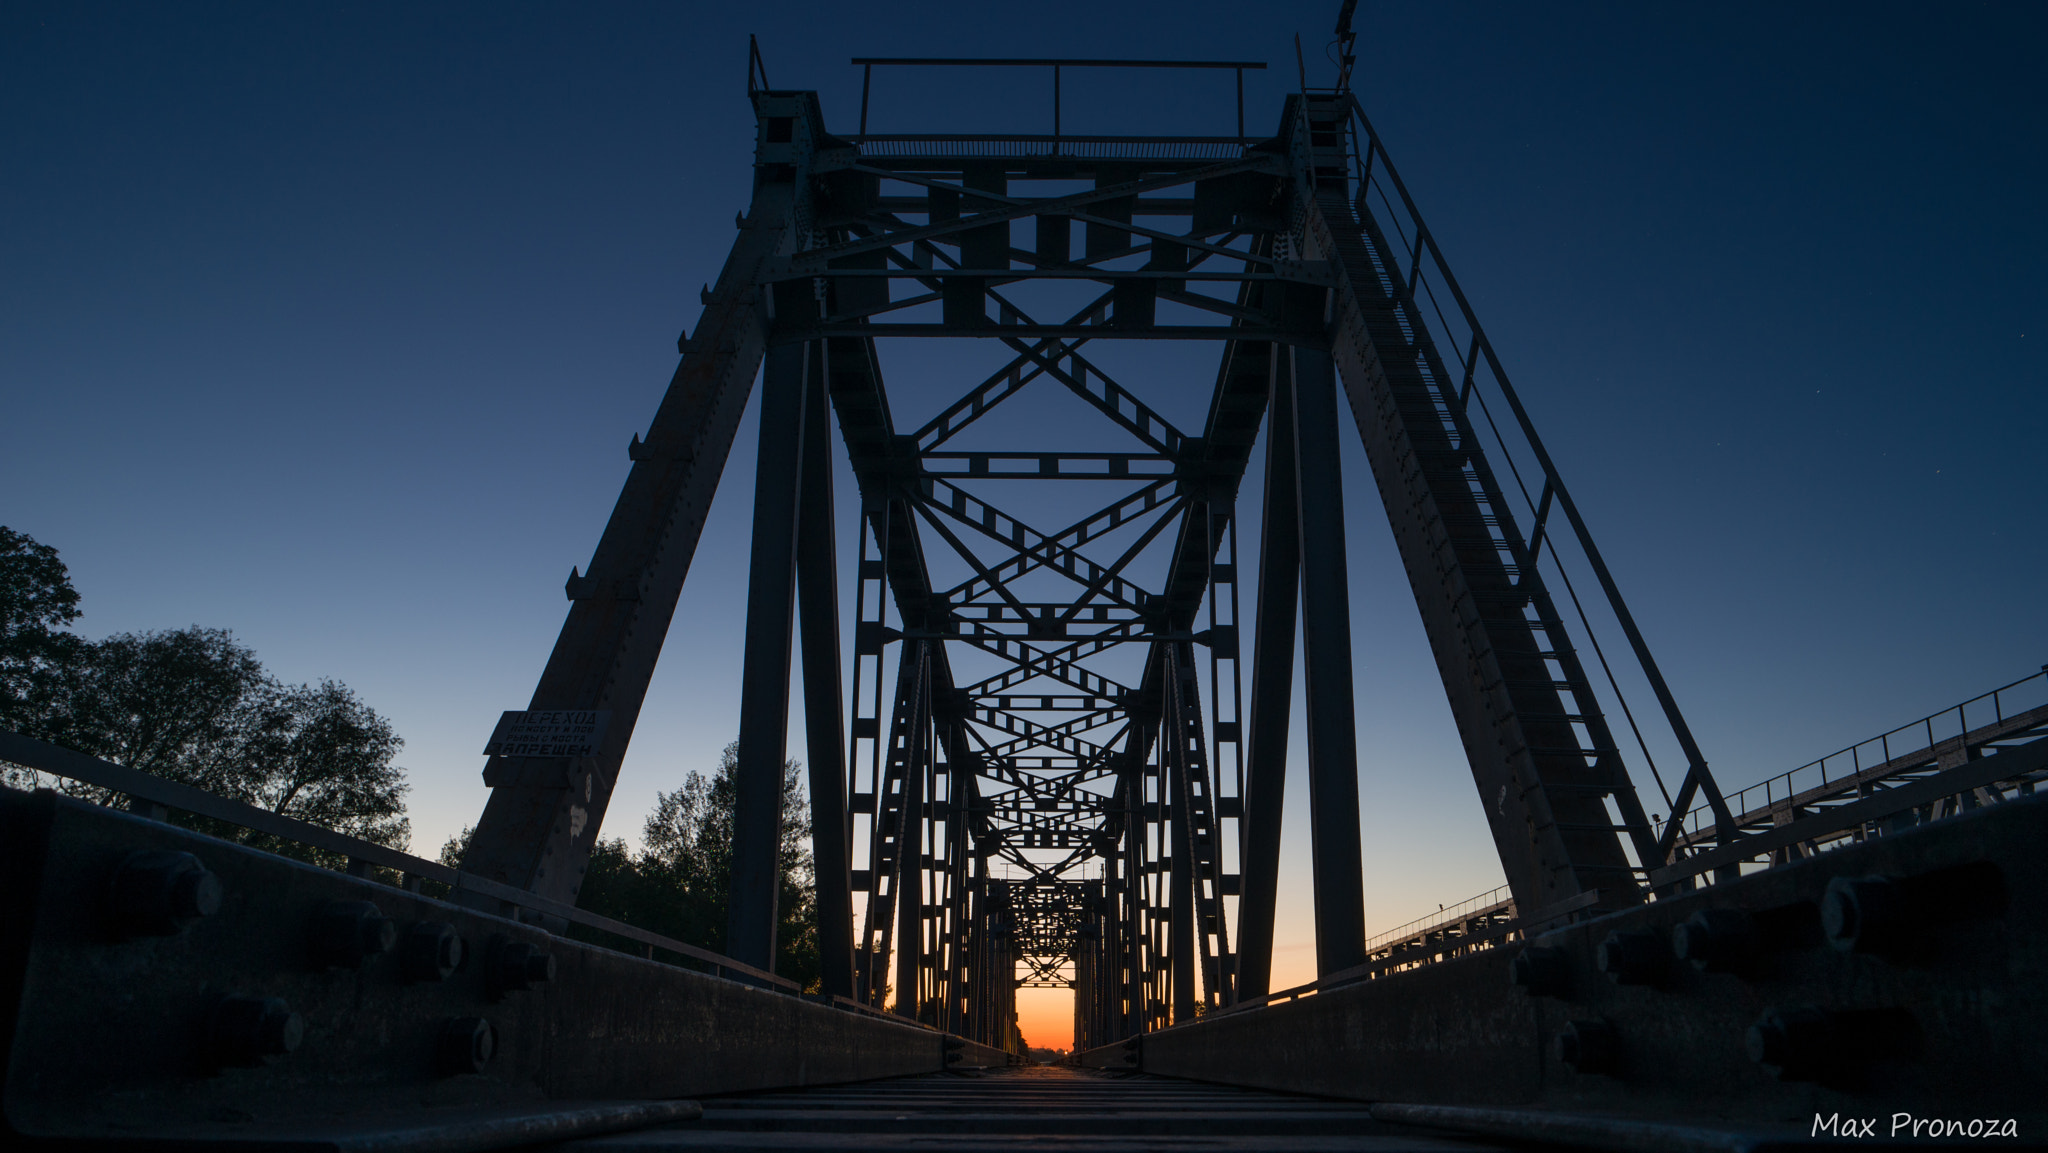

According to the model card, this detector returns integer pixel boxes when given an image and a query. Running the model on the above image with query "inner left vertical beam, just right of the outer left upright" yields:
[797,348,854,997]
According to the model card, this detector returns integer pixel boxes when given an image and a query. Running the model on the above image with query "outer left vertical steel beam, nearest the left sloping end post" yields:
[725,344,811,973]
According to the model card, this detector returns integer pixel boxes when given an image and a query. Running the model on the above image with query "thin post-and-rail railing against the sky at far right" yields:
[1679,666,2048,840]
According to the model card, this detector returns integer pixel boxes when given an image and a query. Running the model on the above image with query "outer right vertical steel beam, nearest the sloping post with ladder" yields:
[1292,348,1366,975]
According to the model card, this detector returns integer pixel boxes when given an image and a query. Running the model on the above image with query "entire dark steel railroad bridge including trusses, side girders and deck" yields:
[0,18,2048,1149]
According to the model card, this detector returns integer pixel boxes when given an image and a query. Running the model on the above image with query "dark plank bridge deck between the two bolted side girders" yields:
[567,1065,1499,1153]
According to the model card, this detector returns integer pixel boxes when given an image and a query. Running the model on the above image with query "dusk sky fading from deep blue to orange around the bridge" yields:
[0,0,2048,1044]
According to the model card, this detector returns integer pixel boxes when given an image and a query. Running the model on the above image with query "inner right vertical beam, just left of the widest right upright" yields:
[1237,348,1300,999]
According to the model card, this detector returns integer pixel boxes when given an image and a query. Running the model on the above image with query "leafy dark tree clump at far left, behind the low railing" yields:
[0,528,412,851]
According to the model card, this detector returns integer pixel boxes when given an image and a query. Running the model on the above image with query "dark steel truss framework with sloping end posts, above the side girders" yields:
[465,45,1733,1044]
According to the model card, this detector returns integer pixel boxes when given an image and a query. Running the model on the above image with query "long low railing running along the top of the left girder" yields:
[0,731,928,1028]
